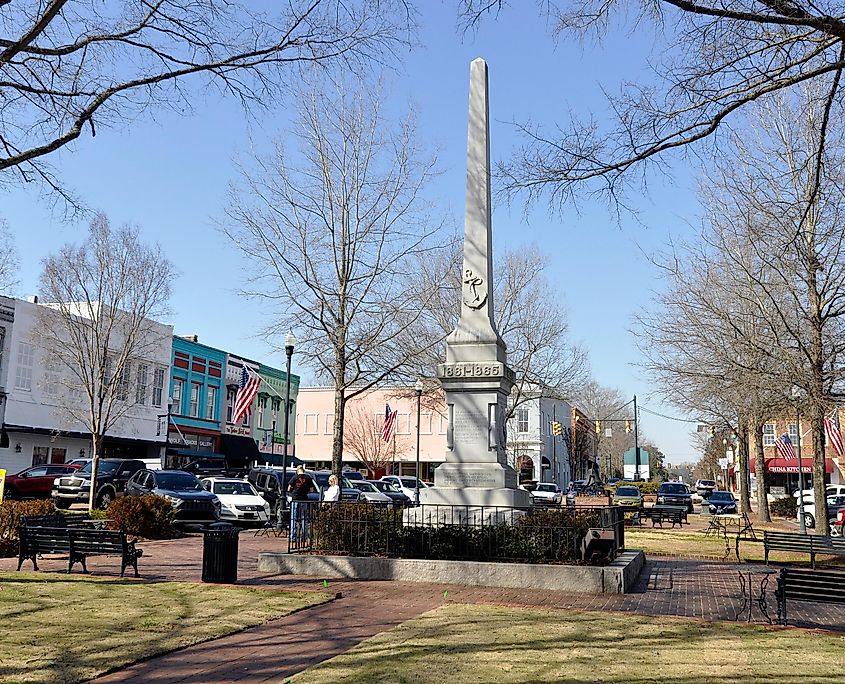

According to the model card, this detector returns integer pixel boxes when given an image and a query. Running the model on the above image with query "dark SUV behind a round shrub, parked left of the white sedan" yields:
[126,469,222,524]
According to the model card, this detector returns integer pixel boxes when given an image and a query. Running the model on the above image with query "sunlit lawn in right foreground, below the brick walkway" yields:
[292,604,845,684]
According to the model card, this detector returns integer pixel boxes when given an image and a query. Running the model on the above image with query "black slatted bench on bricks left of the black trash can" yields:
[18,524,144,577]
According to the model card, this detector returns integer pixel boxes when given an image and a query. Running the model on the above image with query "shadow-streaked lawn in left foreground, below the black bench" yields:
[0,572,328,683]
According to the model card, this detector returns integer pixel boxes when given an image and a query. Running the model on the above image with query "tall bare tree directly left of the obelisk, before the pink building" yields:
[226,76,443,473]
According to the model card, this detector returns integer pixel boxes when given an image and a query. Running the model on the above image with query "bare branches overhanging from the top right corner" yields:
[460,0,845,212]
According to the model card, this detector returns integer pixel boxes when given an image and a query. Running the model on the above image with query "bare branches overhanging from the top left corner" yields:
[0,0,414,208]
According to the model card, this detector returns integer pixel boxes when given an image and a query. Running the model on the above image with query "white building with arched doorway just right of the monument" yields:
[507,397,572,489]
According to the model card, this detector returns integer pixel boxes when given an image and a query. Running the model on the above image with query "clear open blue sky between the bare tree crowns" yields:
[0,2,697,462]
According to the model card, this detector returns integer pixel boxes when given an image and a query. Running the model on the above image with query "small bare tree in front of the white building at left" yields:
[36,215,174,508]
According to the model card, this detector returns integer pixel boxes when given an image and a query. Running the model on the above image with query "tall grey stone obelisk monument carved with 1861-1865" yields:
[420,58,529,508]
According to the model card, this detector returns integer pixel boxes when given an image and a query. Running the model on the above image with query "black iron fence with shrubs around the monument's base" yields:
[289,502,625,563]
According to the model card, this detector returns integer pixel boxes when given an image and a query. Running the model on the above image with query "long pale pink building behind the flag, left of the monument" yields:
[295,387,447,482]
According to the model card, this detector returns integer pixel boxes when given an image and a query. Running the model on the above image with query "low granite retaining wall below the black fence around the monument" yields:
[258,550,645,594]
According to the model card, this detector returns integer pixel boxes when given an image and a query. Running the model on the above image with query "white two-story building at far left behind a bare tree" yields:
[0,297,173,473]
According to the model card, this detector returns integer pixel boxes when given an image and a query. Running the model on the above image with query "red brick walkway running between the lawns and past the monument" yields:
[6,533,845,684]
